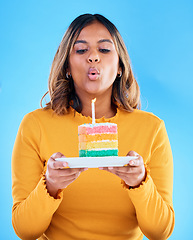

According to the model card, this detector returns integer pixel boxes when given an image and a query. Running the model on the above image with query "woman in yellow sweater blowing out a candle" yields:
[12,14,174,240]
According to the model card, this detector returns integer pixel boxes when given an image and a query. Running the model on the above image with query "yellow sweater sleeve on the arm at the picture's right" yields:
[123,121,174,240]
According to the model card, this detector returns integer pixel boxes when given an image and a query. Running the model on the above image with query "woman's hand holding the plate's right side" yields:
[99,151,146,187]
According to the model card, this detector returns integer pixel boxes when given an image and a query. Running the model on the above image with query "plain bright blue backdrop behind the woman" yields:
[0,0,193,240]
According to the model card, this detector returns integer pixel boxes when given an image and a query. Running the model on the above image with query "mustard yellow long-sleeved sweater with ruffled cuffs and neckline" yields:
[12,109,174,240]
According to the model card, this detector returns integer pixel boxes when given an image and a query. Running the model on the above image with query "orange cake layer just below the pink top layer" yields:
[78,133,118,142]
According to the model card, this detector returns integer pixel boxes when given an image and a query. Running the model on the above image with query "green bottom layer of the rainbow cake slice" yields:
[79,149,118,157]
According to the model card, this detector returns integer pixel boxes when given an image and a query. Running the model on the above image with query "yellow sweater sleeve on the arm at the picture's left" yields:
[12,113,63,240]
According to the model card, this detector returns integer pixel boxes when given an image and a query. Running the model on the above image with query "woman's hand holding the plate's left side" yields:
[45,152,85,198]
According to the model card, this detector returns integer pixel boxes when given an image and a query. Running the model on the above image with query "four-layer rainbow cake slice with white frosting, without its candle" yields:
[78,123,118,157]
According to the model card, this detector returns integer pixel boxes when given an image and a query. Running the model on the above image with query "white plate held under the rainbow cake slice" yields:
[56,156,137,168]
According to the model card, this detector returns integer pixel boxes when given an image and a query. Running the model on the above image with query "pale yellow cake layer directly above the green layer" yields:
[79,140,118,150]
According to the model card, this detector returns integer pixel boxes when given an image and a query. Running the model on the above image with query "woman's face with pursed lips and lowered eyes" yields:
[68,22,119,98]
